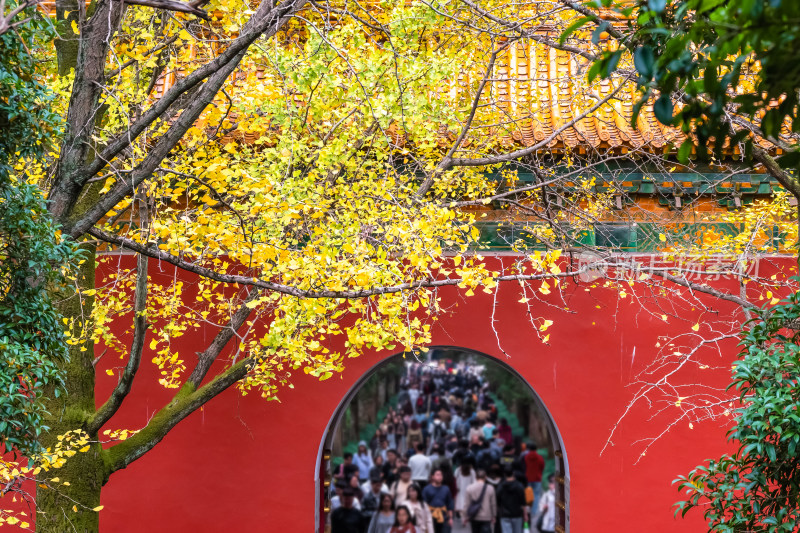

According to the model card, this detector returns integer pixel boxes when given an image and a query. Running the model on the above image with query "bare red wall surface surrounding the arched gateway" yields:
[86,259,788,533]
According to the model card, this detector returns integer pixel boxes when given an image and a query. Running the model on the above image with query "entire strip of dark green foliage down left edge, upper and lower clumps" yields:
[0,0,74,453]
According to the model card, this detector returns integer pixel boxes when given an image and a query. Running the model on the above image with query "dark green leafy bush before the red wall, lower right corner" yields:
[675,293,800,533]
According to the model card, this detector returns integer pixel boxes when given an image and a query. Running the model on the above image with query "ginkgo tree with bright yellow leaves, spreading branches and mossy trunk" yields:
[4,0,796,531]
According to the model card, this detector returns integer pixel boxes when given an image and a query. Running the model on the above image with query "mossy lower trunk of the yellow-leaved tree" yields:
[36,245,106,533]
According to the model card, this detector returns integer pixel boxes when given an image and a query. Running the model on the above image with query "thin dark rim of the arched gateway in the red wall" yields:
[314,346,570,533]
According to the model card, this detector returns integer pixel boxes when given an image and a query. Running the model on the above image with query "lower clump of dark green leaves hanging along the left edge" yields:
[0,178,73,451]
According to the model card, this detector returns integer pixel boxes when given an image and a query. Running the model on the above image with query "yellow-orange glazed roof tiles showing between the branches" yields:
[40,0,776,152]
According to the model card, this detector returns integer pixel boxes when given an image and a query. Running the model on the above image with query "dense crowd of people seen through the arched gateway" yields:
[330,363,556,533]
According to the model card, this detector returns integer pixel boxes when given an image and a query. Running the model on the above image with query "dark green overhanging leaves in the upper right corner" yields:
[570,0,800,169]
